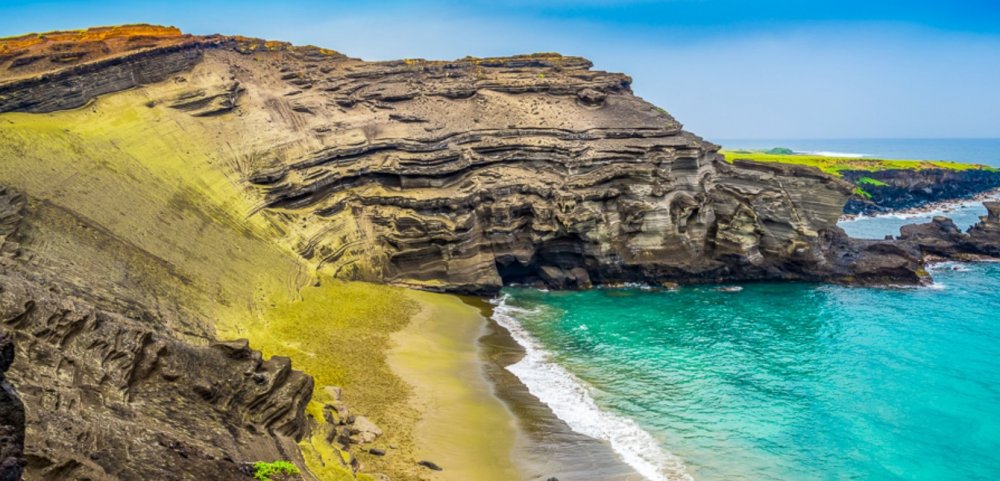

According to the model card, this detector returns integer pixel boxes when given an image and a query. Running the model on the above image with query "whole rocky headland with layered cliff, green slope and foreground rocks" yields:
[0,25,998,480]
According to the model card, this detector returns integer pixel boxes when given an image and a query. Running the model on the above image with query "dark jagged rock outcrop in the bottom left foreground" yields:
[0,189,312,480]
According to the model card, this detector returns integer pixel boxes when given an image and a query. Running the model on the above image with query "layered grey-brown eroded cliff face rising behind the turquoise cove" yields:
[0,24,916,293]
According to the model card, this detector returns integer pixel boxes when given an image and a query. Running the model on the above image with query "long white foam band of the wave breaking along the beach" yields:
[492,295,694,481]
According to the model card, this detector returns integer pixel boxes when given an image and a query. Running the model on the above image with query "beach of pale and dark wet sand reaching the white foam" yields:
[388,291,643,481]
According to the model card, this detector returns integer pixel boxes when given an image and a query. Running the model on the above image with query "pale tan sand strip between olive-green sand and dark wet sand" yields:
[388,291,520,481]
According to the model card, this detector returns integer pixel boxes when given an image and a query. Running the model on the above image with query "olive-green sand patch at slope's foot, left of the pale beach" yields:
[224,280,420,480]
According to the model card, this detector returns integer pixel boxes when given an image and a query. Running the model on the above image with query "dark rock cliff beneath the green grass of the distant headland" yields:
[841,168,1000,215]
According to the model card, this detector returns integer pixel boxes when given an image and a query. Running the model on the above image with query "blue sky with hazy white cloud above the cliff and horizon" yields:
[0,0,1000,139]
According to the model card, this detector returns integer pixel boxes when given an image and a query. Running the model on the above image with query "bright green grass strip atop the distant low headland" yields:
[720,147,997,176]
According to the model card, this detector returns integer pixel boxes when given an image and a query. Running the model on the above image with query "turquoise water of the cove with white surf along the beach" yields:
[494,142,1000,481]
